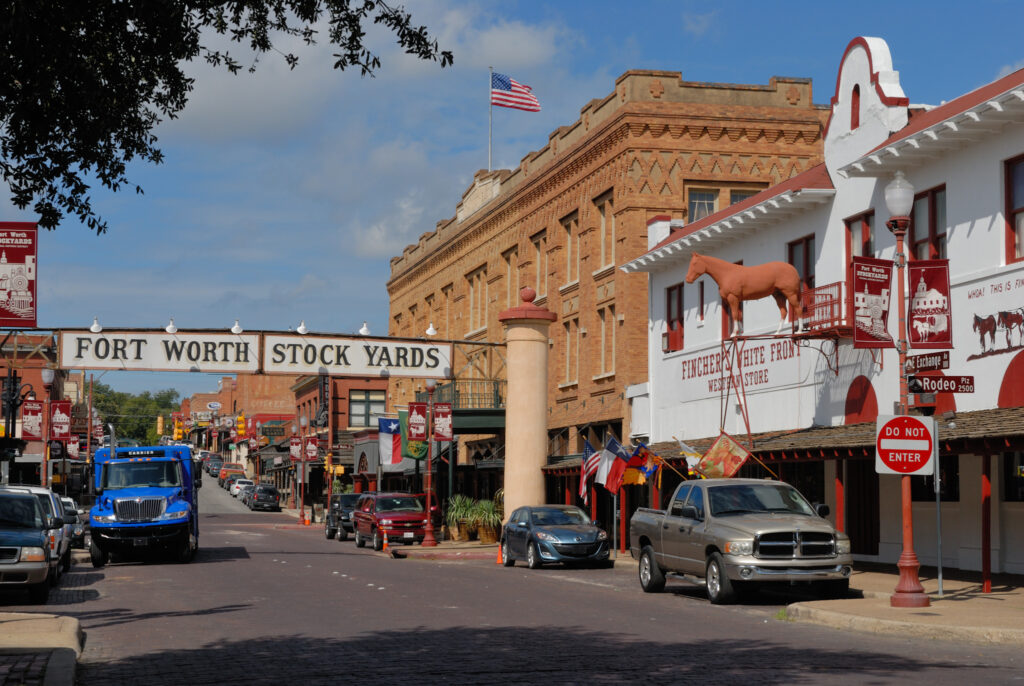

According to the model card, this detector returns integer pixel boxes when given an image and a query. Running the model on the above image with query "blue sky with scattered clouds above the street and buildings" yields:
[0,0,1024,401]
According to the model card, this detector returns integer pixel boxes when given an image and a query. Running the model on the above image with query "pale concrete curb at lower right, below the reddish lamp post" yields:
[785,606,1024,646]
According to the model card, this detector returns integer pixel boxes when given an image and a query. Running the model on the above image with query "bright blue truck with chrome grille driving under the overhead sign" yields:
[89,445,202,567]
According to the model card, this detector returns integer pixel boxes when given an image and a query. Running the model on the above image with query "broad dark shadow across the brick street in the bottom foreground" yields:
[77,627,978,686]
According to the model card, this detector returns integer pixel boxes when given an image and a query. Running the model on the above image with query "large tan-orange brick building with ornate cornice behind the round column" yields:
[388,71,827,502]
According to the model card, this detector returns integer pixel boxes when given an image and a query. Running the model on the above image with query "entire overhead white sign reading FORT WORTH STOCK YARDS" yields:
[59,330,452,379]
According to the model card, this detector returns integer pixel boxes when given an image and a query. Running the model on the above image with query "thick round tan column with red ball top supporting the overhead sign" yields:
[498,287,557,519]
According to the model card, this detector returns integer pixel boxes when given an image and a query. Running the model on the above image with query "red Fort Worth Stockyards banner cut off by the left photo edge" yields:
[0,221,38,328]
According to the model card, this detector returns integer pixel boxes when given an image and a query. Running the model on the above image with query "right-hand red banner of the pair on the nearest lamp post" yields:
[906,260,953,348]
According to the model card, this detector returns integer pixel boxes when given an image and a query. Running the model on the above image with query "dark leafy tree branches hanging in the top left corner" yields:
[0,0,453,233]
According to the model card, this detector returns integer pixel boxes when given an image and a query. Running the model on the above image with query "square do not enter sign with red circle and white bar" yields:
[874,415,939,476]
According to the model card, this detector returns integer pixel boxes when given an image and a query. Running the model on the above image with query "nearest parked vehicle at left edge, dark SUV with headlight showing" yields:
[0,490,58,604]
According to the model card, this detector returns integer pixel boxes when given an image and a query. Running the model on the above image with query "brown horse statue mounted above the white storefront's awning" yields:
[686,253,804,338]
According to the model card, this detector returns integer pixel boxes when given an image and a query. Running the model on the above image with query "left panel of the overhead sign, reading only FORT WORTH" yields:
[60,331,259,373]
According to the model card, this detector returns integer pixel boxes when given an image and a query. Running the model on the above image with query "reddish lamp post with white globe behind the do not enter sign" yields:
[886,171,931,607]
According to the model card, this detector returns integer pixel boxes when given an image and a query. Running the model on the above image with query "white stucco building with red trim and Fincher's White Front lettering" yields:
[622,38,1024,573]
